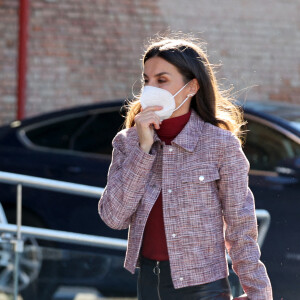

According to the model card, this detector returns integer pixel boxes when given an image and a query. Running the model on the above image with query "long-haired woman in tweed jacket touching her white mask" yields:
[99,34,272,300]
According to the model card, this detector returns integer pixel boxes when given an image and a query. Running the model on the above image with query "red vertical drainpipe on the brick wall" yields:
[17,0,29,120]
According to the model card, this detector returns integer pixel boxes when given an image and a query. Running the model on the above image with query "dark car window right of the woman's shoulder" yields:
[244,120,300,171]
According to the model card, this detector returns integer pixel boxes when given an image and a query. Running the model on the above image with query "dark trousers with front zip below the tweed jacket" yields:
[137,257,232,300]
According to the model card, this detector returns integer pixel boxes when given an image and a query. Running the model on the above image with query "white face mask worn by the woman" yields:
[140,81,194,121]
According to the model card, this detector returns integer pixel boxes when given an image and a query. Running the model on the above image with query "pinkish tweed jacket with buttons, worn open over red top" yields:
[98,109,273,300]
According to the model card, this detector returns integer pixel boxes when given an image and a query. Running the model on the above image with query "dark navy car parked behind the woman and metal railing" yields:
[0,101,300,299]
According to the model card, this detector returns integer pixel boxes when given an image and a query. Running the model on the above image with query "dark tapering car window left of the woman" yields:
[26,110,124,154]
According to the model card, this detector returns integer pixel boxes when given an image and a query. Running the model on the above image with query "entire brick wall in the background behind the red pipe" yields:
[0,0,300,123]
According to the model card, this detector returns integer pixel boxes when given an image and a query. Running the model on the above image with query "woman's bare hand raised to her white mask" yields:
[134,105,163,153]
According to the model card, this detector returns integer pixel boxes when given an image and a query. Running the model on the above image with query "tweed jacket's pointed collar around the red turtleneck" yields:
[153,108,205,152]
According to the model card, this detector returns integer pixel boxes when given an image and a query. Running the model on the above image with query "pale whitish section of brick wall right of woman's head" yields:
[159,0,300,104]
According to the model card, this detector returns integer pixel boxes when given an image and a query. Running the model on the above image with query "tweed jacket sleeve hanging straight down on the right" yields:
[218,134,273,300]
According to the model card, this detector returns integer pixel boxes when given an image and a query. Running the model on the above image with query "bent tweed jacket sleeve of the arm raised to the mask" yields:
[98,131,155,229]
